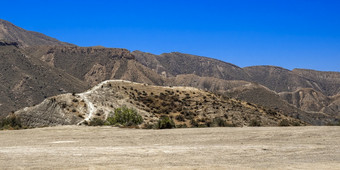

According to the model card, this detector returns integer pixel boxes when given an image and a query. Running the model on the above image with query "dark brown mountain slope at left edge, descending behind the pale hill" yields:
[0,43,89,116]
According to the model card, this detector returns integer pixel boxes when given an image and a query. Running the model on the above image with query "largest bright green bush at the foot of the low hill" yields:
[106,106,143,126]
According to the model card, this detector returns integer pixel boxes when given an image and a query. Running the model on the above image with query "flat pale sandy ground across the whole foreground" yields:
[0,126,340,169]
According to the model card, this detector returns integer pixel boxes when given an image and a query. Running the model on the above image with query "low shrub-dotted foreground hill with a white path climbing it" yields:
[15,80,305,127]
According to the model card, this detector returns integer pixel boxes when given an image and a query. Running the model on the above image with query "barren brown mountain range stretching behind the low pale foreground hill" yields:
[0,19,340,125]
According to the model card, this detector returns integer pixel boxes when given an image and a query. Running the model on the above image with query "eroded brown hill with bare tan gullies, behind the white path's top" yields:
[25,46,163,86]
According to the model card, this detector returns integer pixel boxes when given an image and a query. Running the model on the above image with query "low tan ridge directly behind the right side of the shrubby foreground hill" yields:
[166,74,336,125]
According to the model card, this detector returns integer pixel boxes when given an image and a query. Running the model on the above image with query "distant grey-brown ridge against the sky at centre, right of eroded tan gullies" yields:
[132,51,249,80]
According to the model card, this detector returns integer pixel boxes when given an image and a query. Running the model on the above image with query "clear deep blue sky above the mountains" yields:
[0,0,340,71]
